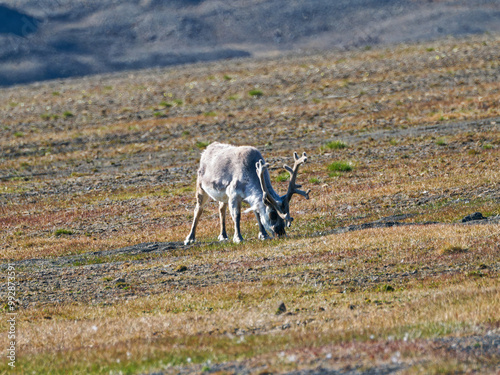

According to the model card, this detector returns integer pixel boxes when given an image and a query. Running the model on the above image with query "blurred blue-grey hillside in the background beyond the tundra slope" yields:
[0,0,500,86]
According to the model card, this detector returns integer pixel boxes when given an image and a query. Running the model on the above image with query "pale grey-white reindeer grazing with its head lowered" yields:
[184,142,310,245]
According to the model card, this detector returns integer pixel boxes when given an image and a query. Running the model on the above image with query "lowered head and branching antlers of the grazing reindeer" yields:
[255,152,311,237]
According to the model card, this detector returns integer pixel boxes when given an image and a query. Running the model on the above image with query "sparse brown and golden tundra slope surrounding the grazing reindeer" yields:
[0,35,500,374]
